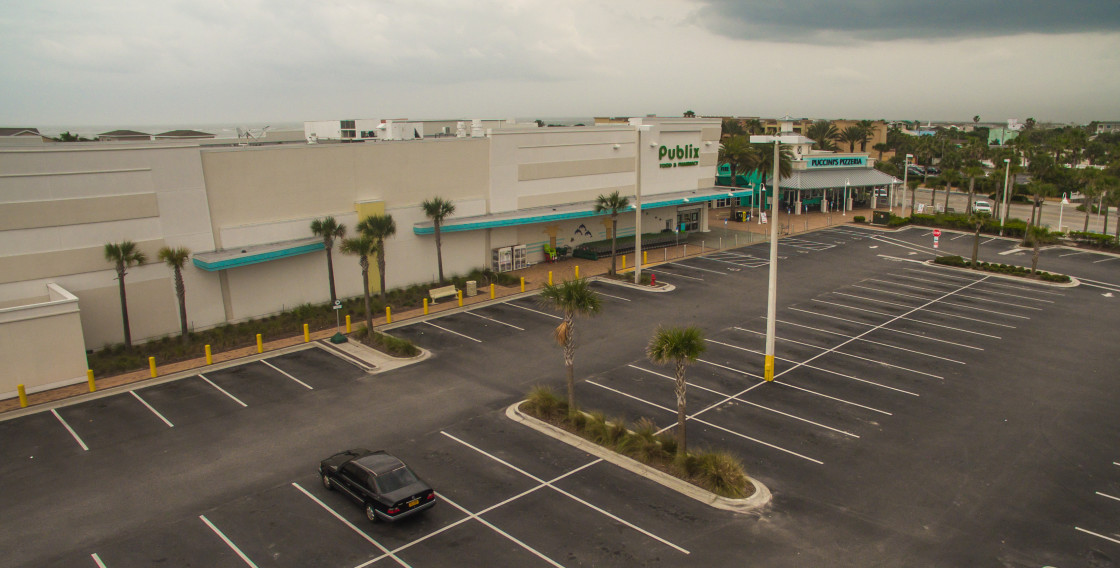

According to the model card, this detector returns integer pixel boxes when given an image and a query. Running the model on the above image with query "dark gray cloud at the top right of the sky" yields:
[693,0,1120,44]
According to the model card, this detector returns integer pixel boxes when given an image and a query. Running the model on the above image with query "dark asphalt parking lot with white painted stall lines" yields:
[0,226,1120,568]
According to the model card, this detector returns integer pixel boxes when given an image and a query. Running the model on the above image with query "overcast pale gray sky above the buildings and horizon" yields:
[0,0,1120,127]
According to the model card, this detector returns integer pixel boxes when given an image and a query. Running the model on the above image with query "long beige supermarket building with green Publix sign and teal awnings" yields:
[0,118,750,395]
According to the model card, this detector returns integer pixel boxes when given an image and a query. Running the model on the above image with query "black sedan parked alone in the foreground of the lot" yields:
[319,448,436,521]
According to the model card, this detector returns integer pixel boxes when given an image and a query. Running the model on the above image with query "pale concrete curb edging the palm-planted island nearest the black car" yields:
[505,401,773,513]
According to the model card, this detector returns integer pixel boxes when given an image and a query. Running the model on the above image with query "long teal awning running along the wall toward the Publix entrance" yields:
[412,187,752,234]
